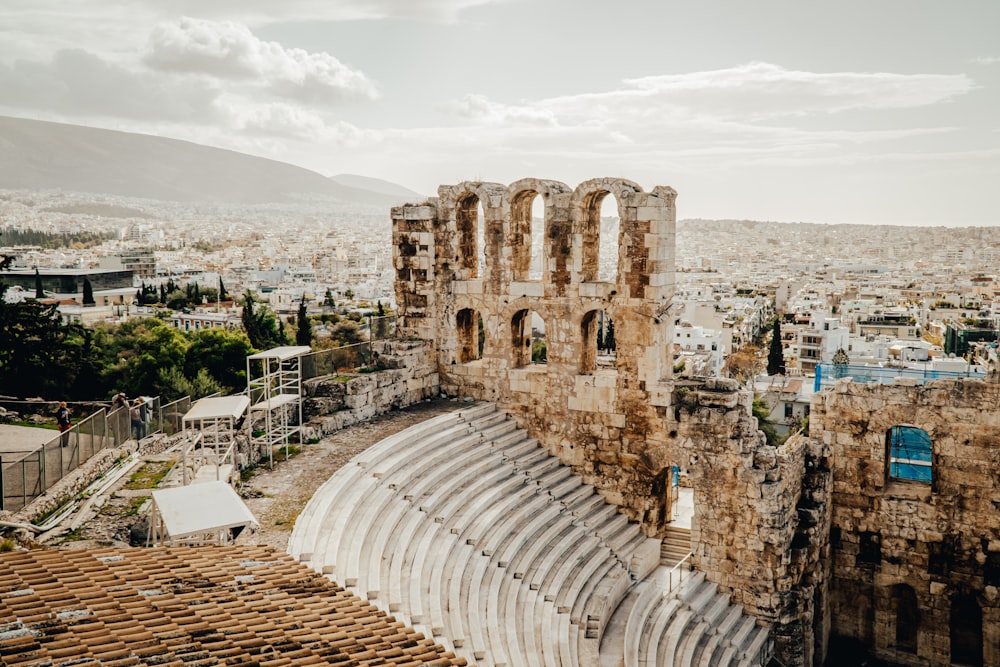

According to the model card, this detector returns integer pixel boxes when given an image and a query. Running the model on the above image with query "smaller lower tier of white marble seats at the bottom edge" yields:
[601,566,771,667]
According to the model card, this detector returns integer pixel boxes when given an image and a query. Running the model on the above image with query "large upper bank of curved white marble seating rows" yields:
[288,404,660,667]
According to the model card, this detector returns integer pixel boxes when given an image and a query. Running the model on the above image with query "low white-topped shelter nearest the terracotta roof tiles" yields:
[150,482,258,544]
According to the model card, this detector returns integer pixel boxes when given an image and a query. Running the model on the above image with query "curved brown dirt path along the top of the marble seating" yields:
[237,399,463,551]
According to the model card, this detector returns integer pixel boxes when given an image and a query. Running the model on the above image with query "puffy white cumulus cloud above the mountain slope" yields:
[143,17,378,103]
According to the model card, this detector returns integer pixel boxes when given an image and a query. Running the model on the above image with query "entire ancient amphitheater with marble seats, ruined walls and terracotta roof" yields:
[0,178,1000,667]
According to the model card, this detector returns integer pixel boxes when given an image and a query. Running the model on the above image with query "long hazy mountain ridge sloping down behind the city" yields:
[0,116,419,206]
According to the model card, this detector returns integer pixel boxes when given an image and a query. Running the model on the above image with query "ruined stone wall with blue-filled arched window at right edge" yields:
[810,380,1000,665]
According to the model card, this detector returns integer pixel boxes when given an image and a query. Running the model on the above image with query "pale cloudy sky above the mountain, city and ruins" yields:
[0,0,1000,226]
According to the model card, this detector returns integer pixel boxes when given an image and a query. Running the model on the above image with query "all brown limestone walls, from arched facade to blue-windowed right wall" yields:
[388,178,1000,665]
